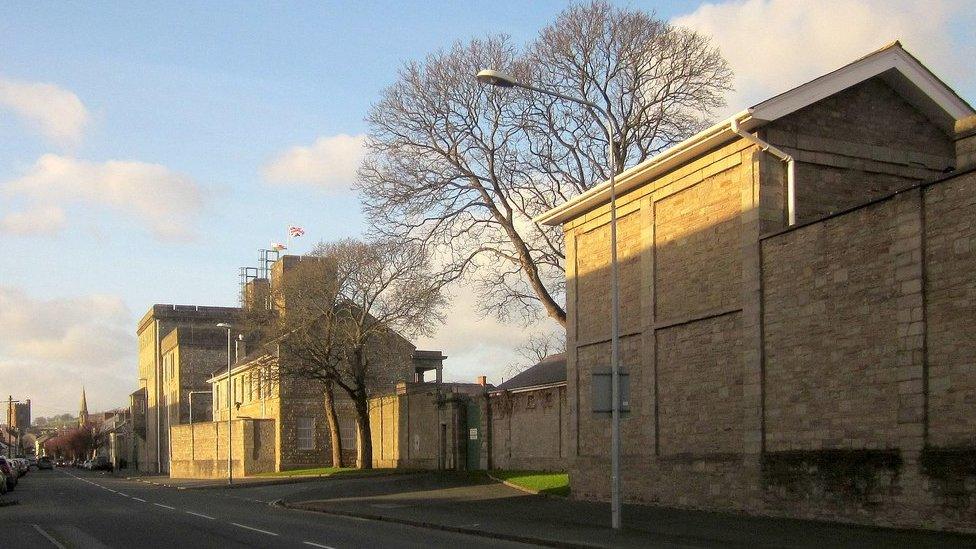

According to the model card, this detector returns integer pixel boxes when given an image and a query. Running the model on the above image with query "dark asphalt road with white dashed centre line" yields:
[0,469,525,549]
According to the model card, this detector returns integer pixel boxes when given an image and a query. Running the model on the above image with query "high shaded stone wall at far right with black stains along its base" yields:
[762,172,976,531]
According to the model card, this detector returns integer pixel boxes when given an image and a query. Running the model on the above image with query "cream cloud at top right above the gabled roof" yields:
[673,0,976,114]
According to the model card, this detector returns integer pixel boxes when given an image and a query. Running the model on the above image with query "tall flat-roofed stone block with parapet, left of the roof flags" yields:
[130,305,240,473]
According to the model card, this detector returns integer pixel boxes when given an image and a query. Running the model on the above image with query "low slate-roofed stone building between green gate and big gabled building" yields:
[482,353,569,471]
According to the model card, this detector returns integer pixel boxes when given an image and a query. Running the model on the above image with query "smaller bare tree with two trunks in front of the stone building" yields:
[273,240,444,469]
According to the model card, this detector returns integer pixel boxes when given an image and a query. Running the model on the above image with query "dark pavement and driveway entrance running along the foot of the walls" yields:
[236,473,976,549]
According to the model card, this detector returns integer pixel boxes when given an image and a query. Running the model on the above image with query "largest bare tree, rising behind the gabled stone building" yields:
[358,1,732,326]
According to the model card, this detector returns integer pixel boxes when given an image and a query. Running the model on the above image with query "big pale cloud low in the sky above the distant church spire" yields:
[0,286,136,416]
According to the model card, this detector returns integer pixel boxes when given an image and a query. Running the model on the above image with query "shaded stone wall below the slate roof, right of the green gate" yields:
[482,385,569,471]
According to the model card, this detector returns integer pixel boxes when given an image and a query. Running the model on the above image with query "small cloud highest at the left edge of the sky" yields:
[0,78,90,144]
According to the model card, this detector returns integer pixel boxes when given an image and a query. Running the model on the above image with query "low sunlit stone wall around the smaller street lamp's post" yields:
[169,419,275,478]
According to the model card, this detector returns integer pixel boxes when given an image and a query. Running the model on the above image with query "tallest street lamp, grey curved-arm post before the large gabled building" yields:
[476,70,621,529]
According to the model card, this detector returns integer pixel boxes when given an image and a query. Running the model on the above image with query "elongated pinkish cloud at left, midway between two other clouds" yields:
[0,154,204,241]
